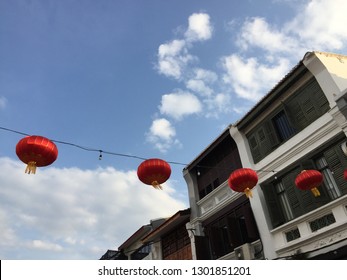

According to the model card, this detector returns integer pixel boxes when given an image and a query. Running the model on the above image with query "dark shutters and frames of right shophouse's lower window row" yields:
[260,139,347,228]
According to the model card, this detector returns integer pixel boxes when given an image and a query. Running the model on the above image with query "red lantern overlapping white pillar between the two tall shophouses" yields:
[228,168,258,197]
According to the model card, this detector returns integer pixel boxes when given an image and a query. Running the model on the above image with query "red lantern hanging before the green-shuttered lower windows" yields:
[295,170,323,196]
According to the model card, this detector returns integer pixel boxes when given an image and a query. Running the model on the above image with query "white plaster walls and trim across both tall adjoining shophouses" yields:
[183,52,347,259]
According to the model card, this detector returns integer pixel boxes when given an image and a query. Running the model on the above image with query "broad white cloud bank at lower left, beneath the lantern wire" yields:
[0,158,186,259]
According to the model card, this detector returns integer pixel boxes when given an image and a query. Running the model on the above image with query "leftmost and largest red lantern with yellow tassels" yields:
[16,135,58,174]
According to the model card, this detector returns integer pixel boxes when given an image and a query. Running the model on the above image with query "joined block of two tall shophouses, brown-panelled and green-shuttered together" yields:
[183,52,347,259]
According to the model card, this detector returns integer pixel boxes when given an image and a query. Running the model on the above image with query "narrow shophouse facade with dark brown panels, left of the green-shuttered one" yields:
[183,129,262,259]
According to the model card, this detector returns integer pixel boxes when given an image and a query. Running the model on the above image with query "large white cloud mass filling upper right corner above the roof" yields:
[222,0,347,104]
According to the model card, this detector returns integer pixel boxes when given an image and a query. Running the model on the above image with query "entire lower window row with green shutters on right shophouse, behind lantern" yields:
[261,139,347,228]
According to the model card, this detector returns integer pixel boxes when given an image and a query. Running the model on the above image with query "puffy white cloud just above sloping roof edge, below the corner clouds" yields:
[222,54,289,101]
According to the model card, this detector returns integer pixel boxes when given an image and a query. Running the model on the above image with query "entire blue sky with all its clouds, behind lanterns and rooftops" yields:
[0,0,347,259]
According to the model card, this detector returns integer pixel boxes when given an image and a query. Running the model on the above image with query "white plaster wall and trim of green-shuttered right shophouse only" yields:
[230,53,347,259]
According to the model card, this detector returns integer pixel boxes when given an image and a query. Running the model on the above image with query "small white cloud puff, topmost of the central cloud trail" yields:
[185,13,213,42]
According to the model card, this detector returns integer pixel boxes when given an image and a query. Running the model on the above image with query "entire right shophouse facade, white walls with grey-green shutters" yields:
[230,52,347,259]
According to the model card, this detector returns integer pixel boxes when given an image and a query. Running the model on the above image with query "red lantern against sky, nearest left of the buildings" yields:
[137,158,171,189]
